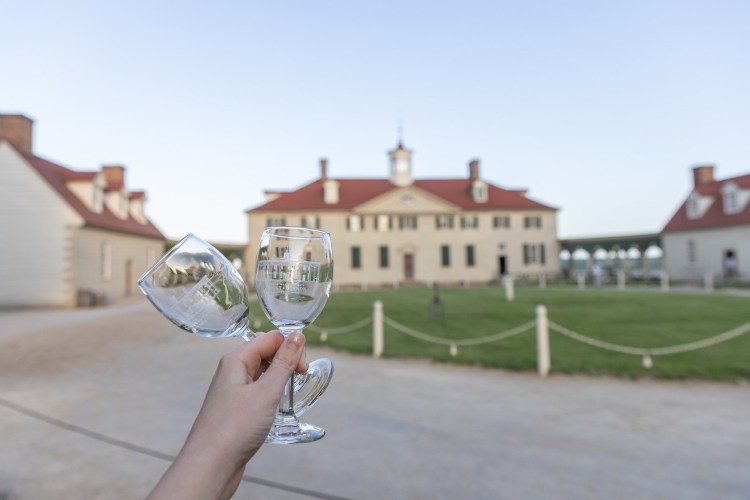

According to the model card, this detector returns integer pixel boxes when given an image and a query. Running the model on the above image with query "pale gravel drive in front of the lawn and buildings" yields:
[0,300,750,500]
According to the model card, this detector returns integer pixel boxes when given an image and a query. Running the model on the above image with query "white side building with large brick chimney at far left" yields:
[0,114,166,307]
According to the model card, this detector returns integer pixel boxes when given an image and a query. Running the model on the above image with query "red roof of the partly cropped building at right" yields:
[662,174,750,233]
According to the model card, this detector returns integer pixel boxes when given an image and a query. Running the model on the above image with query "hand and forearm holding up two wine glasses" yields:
[149,331,307,499]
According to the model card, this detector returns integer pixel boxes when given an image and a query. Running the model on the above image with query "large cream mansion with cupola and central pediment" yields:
[245,143,560,288]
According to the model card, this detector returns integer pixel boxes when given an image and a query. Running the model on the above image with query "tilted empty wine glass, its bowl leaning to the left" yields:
[138,234,329,415]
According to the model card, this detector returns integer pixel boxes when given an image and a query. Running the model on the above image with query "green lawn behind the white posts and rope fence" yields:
[252,286,750,381]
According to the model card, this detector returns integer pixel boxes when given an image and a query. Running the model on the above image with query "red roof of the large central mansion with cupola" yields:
[248,179,557,212]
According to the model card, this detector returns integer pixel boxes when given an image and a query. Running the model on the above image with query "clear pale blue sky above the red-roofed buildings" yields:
[0,0,750,243]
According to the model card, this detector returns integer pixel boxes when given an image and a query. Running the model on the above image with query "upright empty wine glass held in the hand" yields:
[255,227,333,443]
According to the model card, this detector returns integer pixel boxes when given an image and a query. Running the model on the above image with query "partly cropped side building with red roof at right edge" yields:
[661,165,750,280]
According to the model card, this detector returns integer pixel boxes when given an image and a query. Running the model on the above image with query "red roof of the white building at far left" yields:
[23,154,165,239]
